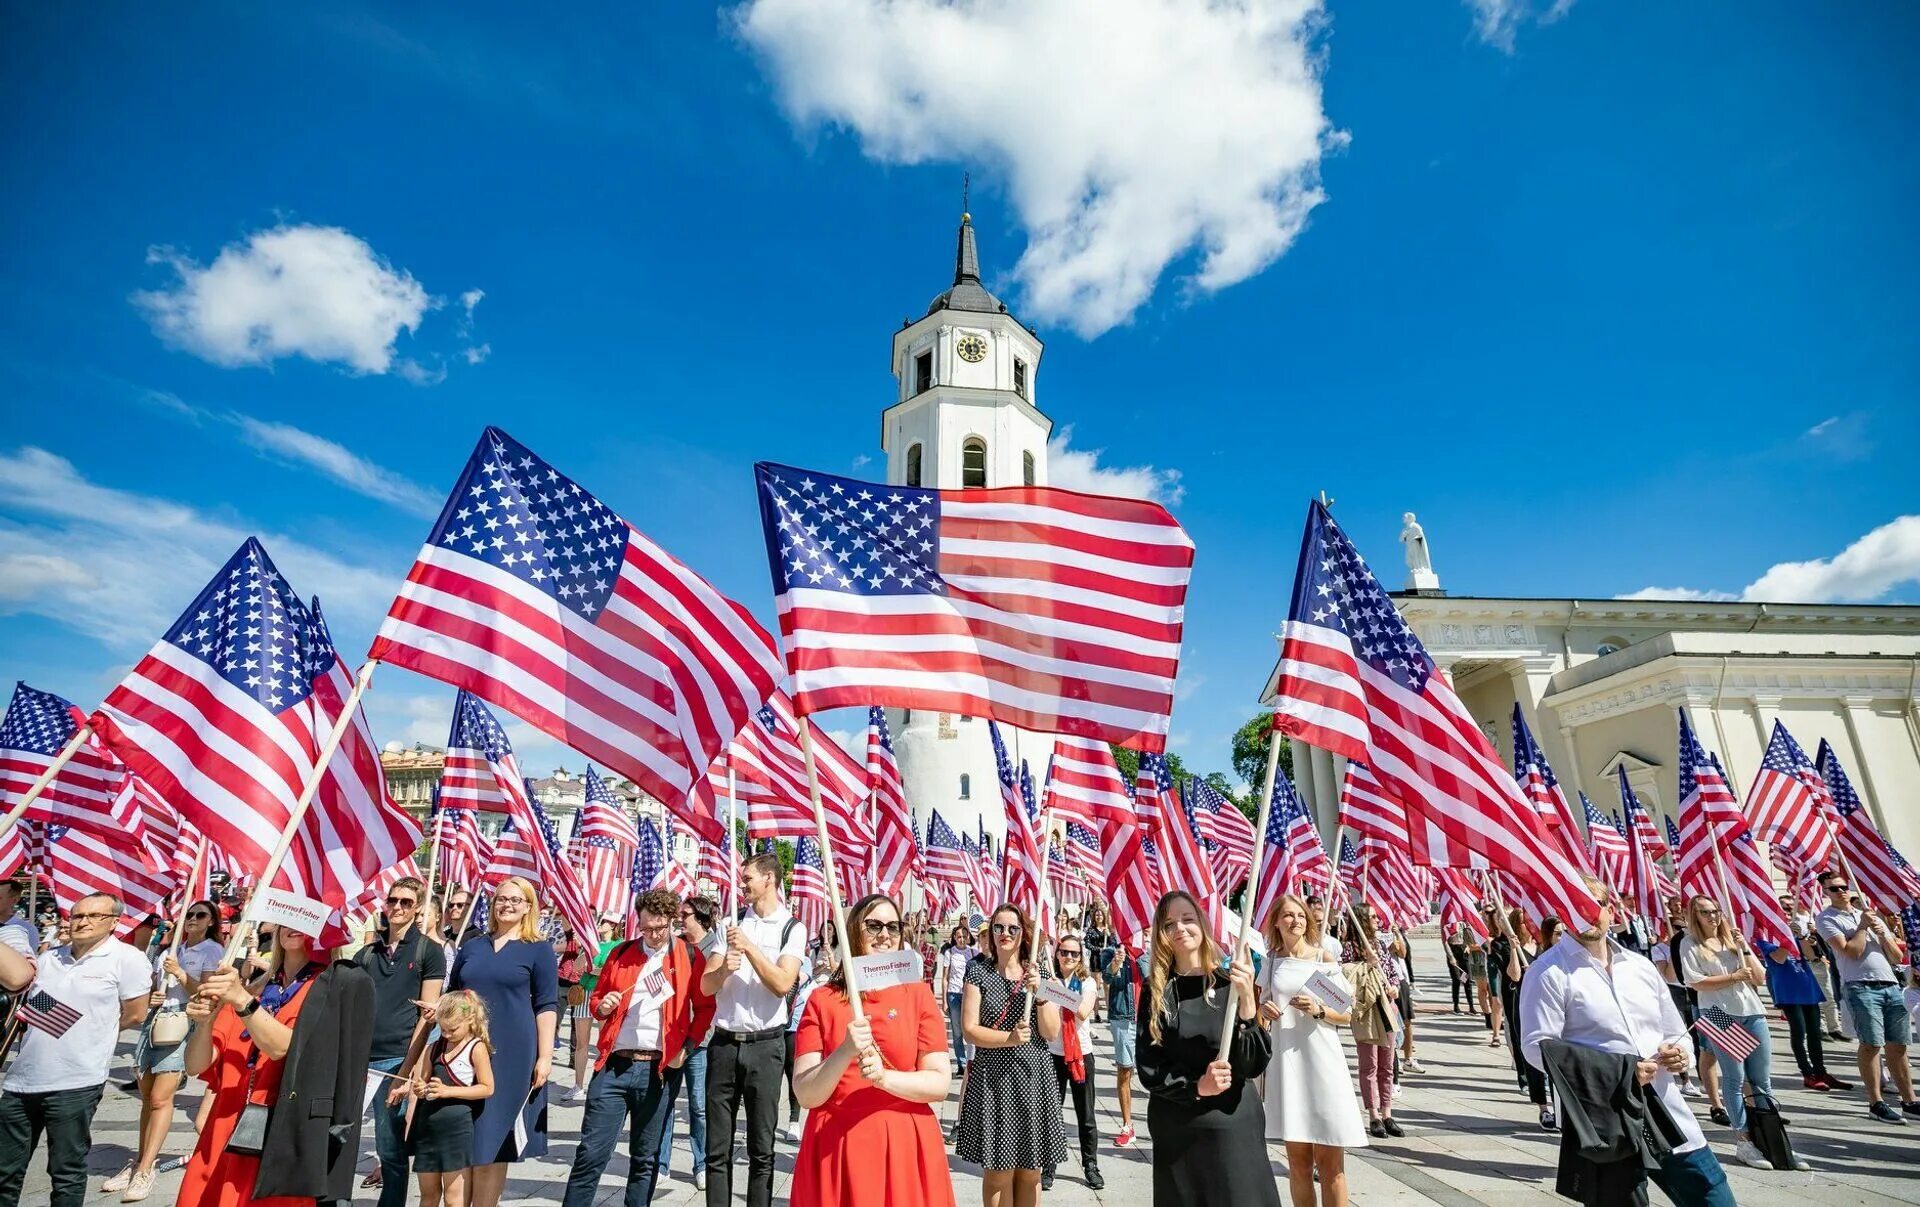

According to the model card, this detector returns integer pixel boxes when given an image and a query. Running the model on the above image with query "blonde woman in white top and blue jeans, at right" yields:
[1680,896,1789,1169]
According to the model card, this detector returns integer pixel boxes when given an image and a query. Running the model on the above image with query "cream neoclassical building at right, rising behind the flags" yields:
[1265,521,1920,854]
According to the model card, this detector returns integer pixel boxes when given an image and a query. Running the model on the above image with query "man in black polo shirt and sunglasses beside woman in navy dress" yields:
[353,875,447,1207]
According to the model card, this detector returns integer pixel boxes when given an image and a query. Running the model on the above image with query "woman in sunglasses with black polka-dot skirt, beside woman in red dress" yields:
[954,906,1068,1207]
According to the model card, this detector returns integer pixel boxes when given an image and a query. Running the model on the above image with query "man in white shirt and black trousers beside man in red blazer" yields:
[701,854,806,1207]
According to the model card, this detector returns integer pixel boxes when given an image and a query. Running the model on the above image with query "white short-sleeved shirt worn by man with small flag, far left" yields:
[4,938,154,1094]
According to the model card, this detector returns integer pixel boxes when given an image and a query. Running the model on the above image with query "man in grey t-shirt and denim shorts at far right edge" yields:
[1812,871,1920,1124]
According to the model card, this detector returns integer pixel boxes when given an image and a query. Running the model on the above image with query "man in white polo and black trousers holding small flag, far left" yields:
[0,892,154,1207]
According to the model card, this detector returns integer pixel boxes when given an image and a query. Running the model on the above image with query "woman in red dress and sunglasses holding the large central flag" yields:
[791,894,954,1207]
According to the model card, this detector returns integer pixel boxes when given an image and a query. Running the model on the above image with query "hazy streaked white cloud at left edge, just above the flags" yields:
[0,447,397,648]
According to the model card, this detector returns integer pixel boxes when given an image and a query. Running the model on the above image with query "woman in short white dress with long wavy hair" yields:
[1260,894,1367,1207]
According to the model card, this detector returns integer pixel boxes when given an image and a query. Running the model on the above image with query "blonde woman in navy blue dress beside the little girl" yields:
[447,877,561,1207]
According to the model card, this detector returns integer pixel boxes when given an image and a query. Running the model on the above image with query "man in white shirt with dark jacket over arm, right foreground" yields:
[1519,879,1734,1207]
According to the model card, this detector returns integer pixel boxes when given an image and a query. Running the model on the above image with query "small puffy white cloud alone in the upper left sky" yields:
[132,226,436,374]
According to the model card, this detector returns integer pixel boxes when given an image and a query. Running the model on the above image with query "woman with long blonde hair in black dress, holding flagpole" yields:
[1135,892,1281,1207]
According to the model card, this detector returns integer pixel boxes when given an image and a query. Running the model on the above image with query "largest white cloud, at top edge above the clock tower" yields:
[733,0,1344,338]
